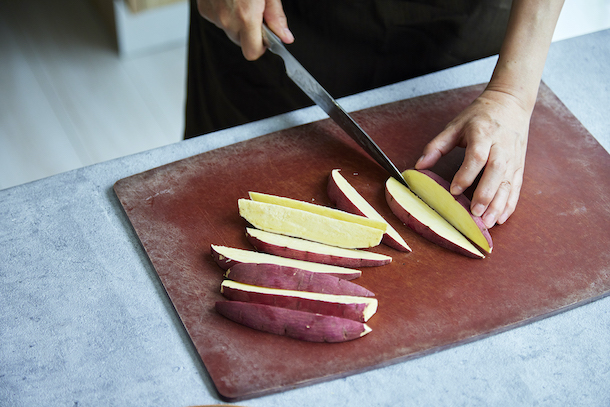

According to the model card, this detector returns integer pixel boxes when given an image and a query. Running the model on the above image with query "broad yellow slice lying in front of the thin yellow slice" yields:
[239,199,384,249]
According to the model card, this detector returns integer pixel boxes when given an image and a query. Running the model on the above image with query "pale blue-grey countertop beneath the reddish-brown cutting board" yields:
[0,31,610,407]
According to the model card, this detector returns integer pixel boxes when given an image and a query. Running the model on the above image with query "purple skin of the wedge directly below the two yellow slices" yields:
[246,233,391,268]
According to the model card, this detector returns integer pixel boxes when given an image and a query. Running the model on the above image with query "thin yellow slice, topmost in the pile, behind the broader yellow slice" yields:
[249,192,387,232]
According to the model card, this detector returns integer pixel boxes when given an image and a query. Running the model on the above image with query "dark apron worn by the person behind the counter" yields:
[185,0,511,138]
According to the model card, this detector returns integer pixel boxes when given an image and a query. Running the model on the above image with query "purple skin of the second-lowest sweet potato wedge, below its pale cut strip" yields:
[222,287,366,322]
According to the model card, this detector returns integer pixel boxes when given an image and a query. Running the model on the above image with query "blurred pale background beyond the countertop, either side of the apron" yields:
[0,0,610,189]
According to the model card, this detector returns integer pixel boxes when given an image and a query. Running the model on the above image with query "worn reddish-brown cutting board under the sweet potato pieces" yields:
[115,84,610,401]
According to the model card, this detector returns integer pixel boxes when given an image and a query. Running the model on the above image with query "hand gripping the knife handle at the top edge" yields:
[197,0,294,61]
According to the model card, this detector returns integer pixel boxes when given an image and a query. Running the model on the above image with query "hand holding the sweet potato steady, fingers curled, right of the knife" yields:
[415,88,531,228]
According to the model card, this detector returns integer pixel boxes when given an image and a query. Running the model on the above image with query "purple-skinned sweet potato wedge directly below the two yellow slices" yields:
[246,228,392,267]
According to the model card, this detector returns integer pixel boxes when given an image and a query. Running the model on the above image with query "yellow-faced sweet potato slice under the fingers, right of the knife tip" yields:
[402,170,491,253]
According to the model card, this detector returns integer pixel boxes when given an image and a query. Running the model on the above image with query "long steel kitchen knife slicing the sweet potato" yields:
[263,24,407,186]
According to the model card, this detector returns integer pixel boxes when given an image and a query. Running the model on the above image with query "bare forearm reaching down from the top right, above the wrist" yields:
[487,0,564,112]
